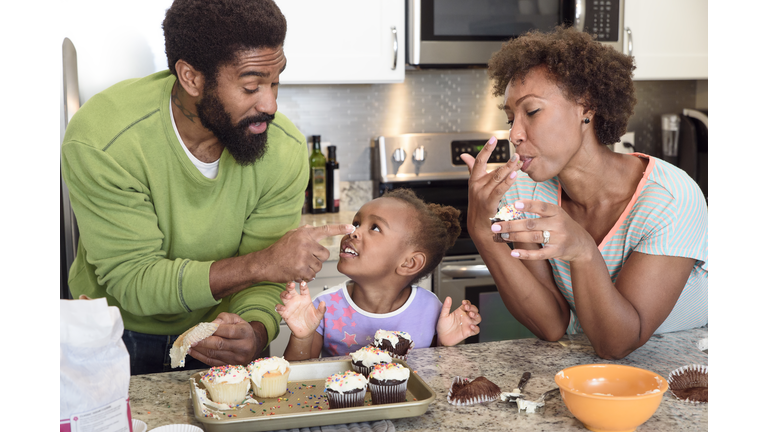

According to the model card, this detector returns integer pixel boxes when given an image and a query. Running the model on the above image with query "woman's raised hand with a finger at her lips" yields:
[461,137,520,238]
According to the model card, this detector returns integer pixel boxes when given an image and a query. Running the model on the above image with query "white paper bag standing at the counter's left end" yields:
[59,298,131,432]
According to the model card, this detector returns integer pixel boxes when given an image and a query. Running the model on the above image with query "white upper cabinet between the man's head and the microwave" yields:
[276,0,405,84]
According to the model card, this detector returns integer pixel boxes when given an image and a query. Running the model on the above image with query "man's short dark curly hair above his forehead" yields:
[163,0,286,78]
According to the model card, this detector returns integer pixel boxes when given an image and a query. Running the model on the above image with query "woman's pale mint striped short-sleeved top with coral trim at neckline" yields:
[501,153,708,333]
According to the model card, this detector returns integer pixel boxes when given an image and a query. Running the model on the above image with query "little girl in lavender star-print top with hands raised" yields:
[275,189,480,361]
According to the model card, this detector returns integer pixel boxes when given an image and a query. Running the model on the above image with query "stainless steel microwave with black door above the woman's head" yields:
[406,0,624,67]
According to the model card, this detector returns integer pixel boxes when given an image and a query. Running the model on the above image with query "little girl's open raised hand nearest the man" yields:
[275,282,326,339]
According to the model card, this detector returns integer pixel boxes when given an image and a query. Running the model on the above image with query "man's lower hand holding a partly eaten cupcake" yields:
[189,312,267,366]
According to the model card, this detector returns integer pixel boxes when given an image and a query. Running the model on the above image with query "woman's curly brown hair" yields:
[488,25,637,145]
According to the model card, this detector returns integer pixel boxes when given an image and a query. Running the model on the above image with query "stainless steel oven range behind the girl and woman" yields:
[371,130,533,343]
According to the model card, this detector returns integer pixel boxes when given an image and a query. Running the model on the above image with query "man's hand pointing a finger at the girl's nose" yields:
[255,225,355,283]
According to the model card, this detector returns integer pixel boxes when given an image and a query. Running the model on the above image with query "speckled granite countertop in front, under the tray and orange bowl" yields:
[129,328,709,432]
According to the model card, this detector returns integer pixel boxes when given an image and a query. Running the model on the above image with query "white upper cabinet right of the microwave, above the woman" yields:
[624,0,708,80]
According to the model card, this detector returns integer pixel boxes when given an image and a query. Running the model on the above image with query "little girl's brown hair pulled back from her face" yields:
[382,188,461,284]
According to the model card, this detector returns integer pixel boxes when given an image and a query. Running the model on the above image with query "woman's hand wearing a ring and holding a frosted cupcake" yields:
[491,200,599,262]
